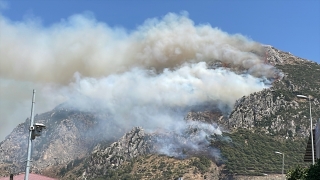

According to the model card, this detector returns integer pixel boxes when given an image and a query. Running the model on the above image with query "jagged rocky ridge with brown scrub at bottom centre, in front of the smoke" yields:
[60,127,221,180]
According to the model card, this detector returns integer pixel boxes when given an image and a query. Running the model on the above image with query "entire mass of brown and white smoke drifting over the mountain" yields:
[0,13,275,153]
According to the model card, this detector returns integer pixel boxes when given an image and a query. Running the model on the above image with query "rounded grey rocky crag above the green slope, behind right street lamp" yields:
[229,90,319,138]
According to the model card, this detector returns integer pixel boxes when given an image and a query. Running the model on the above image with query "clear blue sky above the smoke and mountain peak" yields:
[0,0,320,63]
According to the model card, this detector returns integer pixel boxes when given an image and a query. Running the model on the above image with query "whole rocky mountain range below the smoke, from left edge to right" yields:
[0,46,320,179]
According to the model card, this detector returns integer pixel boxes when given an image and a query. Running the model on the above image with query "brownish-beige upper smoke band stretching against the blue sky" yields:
[0,14,268,85]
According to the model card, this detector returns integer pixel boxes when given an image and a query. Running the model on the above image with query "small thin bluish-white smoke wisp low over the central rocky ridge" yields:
[153,121,222,158]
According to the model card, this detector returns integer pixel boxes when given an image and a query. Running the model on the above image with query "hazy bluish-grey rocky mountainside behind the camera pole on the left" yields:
[0,108,118,175]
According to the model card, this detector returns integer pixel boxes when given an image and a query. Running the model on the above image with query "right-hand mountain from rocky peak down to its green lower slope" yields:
[189,46,320,175]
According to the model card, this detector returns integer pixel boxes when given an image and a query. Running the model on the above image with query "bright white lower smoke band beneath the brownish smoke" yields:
[71,62,267,129]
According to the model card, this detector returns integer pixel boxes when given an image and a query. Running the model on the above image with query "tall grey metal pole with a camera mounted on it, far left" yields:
[24,90,36,180]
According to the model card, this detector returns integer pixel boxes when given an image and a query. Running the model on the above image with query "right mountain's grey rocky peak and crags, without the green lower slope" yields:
[187,46,320,138]
